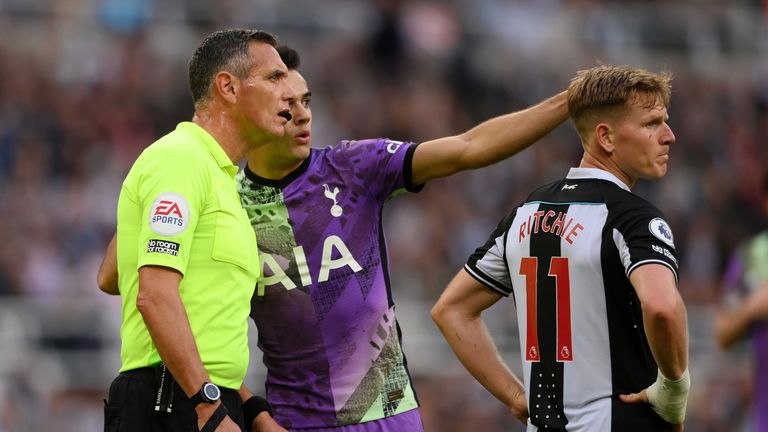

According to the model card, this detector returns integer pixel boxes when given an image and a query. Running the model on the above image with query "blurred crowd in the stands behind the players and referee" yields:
[0,0,768,432]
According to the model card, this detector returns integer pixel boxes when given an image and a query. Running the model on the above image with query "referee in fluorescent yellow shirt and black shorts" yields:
[105,29,290,432]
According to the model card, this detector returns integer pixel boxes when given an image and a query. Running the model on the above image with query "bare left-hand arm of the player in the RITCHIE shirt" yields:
[432,269,528,424]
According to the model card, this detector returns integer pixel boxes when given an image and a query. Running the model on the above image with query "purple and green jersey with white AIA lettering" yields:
[238,139,418,429]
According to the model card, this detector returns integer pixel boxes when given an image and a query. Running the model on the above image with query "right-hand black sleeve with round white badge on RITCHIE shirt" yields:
[613,207,678,280]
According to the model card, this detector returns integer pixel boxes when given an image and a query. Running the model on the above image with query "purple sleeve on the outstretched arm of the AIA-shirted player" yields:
[339,139,421,200]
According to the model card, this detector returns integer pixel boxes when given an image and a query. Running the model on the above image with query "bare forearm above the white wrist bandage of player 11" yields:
[643,297,688,380]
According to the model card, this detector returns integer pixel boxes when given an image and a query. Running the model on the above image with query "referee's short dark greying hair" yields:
[189,29,277,105]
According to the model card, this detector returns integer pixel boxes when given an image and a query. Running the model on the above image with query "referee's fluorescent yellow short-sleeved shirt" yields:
[117,122,260,389]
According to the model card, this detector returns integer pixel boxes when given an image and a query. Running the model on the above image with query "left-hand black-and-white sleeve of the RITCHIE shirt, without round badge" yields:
[464,211,516,297]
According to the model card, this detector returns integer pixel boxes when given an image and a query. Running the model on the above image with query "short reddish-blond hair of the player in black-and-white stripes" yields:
[568,65,672,142]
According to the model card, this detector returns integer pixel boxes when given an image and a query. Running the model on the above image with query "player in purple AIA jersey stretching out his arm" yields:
[238,47,567,432]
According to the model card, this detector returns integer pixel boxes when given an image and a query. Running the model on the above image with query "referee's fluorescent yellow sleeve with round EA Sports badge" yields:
[136,147,210,274]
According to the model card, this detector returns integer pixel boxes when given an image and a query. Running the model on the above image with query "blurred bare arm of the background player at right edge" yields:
[715,284,768,349]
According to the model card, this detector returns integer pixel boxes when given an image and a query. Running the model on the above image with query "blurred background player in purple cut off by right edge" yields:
[715,170,768,432]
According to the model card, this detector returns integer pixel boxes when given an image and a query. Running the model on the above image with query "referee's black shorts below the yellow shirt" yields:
[104,368,243,432]
